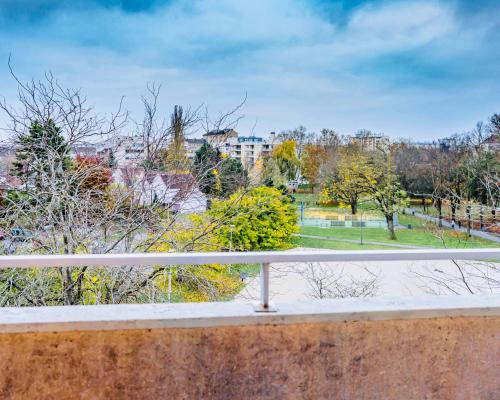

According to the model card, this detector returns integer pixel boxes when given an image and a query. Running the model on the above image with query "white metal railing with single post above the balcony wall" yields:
[0,248,500,311]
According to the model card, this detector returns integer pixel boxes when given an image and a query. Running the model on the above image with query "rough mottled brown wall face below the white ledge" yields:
[0,317,500,400]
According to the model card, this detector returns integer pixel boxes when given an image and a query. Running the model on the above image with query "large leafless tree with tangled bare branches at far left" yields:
[0,63,256,305]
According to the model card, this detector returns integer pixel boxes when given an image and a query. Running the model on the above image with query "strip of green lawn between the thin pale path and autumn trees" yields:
[300,226,500,248]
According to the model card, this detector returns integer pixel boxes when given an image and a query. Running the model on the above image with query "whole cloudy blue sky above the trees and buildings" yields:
[0,0,500,141]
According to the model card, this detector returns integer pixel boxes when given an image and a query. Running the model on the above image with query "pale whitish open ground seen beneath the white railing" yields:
[235,248,500,304]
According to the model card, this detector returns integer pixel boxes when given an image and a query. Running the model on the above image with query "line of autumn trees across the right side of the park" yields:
[261,114,500,238]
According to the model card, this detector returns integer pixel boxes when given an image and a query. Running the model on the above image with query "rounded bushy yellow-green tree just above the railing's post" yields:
[208,186,297,251]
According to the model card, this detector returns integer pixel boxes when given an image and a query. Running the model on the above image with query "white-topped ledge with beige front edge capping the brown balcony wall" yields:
[0,295,500,333]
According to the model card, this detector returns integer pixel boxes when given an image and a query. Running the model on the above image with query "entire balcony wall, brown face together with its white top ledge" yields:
[0,296,500,400]
